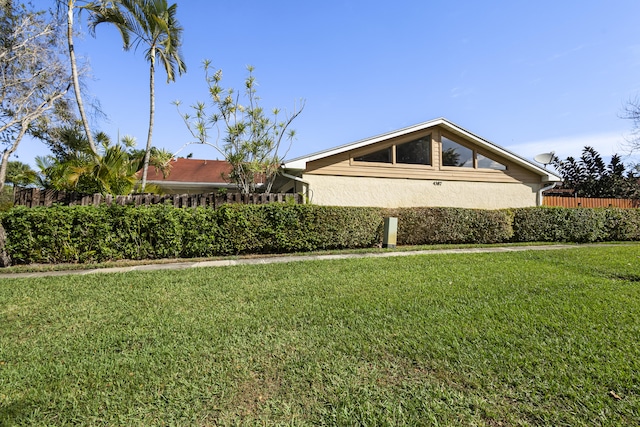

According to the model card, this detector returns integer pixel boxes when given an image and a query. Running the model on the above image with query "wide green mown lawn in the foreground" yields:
[0,245,640,426]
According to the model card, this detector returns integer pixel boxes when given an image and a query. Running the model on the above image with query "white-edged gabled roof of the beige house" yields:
[282,118,562,182]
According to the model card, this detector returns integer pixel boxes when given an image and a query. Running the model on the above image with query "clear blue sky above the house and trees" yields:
[17,0,640,167]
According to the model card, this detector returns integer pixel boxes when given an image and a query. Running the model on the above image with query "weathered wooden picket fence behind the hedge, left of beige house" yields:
[13,188,304,208]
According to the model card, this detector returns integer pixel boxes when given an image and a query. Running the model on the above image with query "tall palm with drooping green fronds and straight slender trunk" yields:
[86,0,187,192]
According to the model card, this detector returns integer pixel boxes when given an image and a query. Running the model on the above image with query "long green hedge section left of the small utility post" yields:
[1,204,382,264]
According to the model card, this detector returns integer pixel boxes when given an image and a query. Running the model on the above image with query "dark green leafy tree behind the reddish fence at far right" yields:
[552,146,640,198]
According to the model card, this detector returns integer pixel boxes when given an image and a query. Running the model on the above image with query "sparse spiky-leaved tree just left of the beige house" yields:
[175,61,304,193]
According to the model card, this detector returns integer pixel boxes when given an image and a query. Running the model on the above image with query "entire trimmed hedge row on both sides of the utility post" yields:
[0,204,640,264]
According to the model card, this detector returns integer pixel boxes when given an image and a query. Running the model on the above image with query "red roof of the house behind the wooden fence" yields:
[147,158,231,183]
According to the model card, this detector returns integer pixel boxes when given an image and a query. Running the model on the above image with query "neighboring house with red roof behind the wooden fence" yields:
[147,158,237,194]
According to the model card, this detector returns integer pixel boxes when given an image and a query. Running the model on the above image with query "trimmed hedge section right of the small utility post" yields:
[385,207,640,245]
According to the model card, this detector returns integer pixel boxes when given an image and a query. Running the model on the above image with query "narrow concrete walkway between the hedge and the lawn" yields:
[0,244,608,279]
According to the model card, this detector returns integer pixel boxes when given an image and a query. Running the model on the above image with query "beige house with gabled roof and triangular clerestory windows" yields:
[279,118,562,209]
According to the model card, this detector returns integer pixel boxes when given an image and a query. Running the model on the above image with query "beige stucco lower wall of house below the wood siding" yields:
[303,174,540,209]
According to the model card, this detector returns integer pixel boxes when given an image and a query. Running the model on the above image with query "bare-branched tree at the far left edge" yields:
[0,1,71,191]
